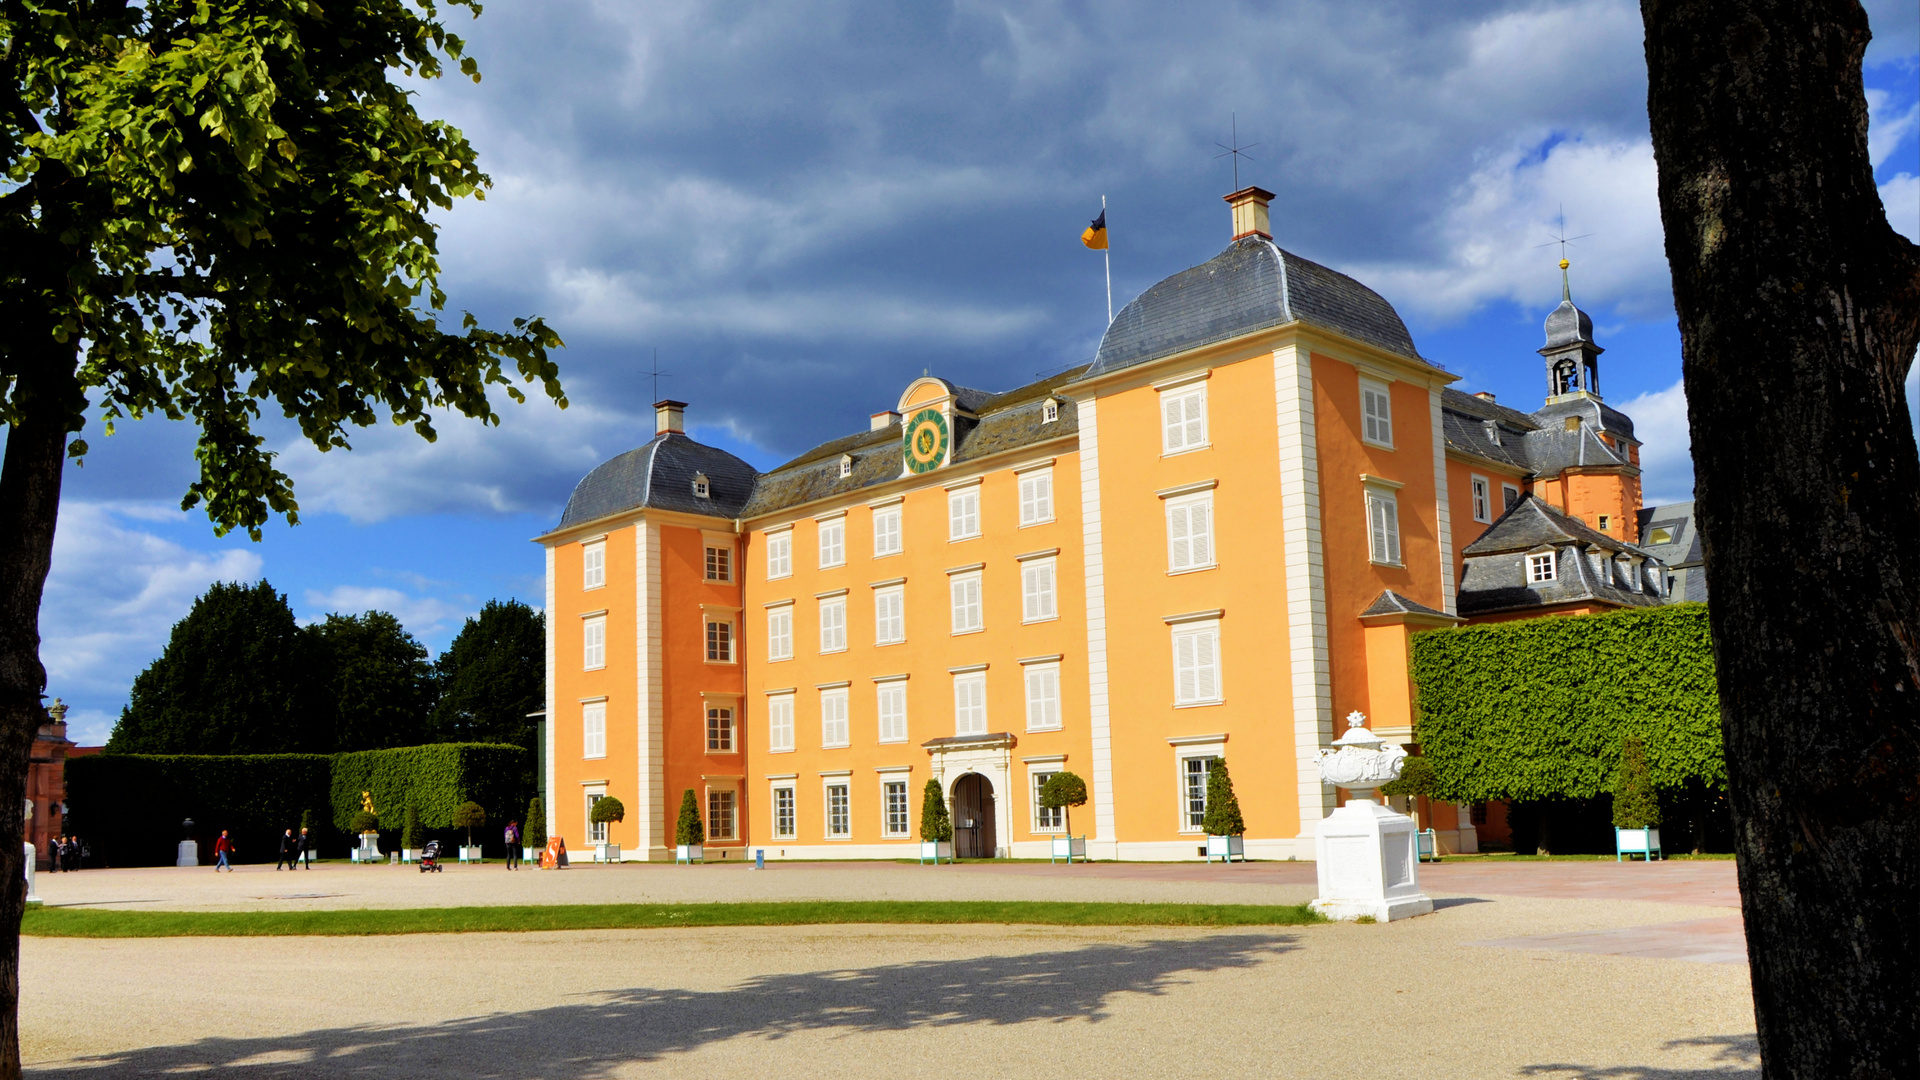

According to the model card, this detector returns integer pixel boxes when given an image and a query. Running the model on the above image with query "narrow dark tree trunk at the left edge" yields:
[0,354,79,1080]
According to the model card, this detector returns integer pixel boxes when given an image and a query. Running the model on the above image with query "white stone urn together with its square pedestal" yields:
[1313,711,1434,922]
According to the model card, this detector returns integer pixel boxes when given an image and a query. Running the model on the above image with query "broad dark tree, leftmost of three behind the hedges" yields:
[108,580,334,753]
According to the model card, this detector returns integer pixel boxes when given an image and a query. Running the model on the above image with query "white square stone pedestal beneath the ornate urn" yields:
[1313,799,1434,922]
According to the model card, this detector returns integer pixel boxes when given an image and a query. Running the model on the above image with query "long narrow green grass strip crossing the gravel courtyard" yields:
[19,901,1323,938]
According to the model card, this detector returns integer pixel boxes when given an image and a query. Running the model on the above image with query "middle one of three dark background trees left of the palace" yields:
[307,611,434,751]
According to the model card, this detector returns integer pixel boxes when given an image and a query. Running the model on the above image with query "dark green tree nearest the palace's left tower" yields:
[430,600,547,757]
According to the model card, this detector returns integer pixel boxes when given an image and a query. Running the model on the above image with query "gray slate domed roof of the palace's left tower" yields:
[561,430,758,528]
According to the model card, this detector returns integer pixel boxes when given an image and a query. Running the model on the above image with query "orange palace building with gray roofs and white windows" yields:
[540,188,1690,859]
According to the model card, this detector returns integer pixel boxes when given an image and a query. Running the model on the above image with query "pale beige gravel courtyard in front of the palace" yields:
[21,861,1759,1080]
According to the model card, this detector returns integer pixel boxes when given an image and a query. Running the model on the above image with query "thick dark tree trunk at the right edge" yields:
[1642,0,1920,1080]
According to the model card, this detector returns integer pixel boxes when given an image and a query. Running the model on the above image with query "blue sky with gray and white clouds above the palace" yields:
[30,0,1920,742]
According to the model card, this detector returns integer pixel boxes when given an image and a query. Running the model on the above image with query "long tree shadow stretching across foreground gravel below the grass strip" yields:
[29,934,1296,1080]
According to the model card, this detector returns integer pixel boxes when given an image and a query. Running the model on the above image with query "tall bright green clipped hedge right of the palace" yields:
[1413,603,1726,801]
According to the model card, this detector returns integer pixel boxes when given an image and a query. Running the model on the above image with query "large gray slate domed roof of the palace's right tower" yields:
[1087,236,1421,377]
